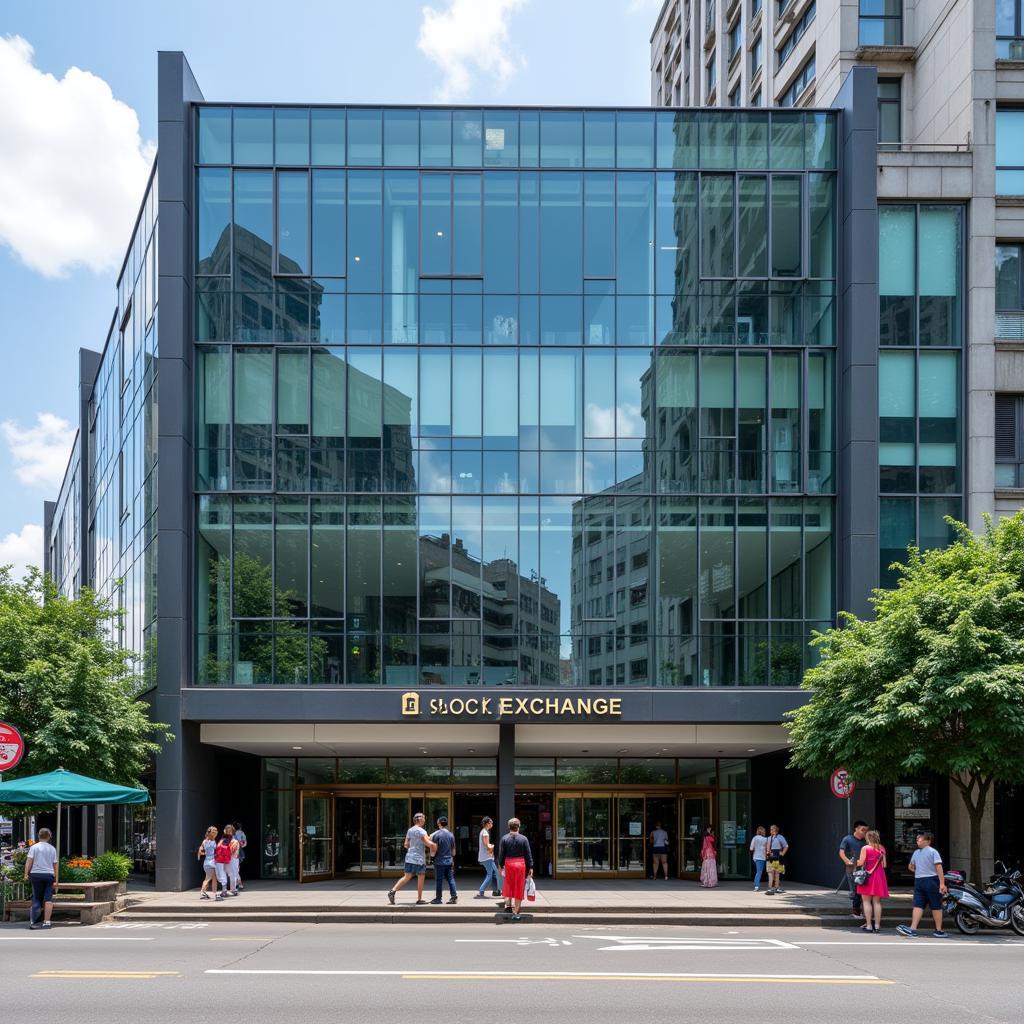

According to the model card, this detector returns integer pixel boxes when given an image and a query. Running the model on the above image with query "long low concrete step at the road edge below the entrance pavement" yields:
[110,904,851,928]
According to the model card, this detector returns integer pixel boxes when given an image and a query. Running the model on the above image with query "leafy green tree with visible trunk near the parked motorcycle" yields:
[790,512,1024,879]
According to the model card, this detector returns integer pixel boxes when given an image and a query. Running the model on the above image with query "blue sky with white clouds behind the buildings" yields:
[0,0,660,567]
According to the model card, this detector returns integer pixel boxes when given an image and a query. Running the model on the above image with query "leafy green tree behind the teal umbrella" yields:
[0,566,174,814]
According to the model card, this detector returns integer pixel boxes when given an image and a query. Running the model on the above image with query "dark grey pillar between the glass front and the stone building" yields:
[835,68,879,616]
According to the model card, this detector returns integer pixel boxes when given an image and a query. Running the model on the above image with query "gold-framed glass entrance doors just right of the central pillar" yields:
[555,793,645,878]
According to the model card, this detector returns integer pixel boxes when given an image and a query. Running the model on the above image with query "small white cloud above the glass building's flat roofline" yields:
[417,0,526,103]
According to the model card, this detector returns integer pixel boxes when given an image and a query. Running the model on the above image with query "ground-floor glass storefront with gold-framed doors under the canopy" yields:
[261,758,751,881]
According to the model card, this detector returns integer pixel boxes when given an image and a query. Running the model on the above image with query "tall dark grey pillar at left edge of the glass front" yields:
[154,51,204,890]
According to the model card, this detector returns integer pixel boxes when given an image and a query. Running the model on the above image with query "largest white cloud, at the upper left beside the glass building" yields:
[0,36,156,276]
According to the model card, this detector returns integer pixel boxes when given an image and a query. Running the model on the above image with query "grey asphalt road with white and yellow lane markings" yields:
[0,923,1024,1024]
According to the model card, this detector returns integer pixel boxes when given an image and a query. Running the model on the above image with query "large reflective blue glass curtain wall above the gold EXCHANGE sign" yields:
[195,106,836,687]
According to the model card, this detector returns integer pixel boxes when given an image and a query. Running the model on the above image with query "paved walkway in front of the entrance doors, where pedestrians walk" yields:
[129,871,910,913]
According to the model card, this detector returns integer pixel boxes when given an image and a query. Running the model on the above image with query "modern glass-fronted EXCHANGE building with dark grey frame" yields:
[47,53,884,889]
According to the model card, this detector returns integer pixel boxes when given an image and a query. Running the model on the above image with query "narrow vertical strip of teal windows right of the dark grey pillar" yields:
[879,204,964,586]
